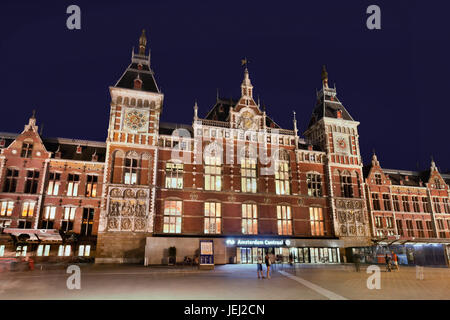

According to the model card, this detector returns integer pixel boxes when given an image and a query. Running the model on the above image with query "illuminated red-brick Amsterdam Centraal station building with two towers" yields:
[0,32,450,265]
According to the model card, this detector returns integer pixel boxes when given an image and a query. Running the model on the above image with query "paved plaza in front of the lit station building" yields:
[0,265,450,300]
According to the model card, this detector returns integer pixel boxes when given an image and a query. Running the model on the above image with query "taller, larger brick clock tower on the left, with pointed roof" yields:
[96,30,163,263]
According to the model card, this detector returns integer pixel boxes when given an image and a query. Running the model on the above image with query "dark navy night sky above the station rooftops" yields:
[0,0,450,171]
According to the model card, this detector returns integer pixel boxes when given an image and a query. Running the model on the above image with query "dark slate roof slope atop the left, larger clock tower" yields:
[115,63,160,93]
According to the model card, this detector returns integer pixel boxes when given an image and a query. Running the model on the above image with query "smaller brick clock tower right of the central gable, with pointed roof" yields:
[305,66,370,247]
